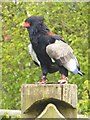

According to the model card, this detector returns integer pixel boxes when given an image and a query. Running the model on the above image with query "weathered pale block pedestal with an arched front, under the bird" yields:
[21,84,77,119]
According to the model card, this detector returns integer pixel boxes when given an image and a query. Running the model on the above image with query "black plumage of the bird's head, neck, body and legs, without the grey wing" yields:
[24,16,84,83]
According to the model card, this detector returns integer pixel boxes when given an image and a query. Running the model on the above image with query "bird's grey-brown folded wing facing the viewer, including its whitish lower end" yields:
[46,40,79,74]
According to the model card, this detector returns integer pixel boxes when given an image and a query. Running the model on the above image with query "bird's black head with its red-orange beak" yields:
[22,16,44,28]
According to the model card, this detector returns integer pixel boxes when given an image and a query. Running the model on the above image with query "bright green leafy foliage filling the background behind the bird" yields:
[1,2,90,115]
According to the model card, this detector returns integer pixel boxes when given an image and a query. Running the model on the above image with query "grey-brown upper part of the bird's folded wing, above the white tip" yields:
[46,40,73,64]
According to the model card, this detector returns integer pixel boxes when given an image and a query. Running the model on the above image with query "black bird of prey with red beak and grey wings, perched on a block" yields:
[22,16,84,84]
